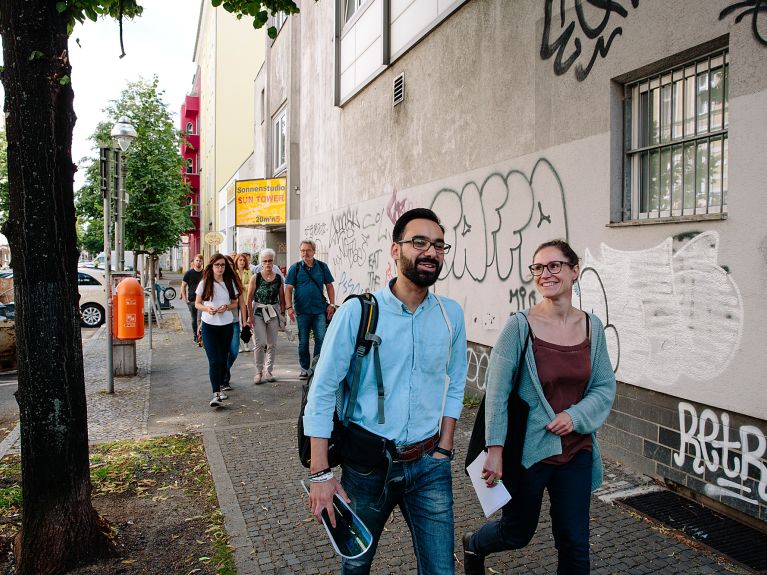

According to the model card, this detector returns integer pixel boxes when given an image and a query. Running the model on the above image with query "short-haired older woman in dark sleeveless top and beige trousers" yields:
[248,248,285,385]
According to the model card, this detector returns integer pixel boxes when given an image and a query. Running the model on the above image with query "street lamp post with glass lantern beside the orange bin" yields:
[100,116,136,393]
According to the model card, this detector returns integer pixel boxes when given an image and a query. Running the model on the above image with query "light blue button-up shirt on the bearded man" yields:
[304,282,466,445]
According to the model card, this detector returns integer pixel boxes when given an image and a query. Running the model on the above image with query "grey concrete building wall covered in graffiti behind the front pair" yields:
[300,0,767,519]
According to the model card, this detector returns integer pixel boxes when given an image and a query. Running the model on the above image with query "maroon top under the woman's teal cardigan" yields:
[530,315,591,465]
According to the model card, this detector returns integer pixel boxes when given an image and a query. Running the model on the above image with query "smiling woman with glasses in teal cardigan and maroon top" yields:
[463,240,615,575]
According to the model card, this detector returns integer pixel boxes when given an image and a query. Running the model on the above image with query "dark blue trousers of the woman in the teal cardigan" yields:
[469,451,591,575]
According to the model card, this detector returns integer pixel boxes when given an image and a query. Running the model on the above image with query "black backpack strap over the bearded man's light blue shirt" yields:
[343,293,385,426]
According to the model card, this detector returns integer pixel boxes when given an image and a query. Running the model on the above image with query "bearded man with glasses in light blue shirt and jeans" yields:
[303,208,467,575]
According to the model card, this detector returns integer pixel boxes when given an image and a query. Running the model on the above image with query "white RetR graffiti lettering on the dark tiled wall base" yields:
[674,401,767,505]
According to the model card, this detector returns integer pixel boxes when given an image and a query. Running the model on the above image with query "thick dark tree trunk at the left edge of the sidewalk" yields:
[0,0,113,575]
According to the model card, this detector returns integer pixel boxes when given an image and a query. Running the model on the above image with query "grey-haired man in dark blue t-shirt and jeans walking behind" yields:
[285,240,336,379]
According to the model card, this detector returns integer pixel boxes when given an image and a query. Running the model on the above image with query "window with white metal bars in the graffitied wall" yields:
[623,49,729,220]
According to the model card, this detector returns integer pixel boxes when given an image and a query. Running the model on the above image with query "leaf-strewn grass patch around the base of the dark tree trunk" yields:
[0,435,236,575]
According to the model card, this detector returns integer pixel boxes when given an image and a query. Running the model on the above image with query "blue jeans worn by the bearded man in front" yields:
[341,455,454,575]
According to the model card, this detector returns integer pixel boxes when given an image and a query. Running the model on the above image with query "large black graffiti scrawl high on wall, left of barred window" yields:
[541,0,639,82]
